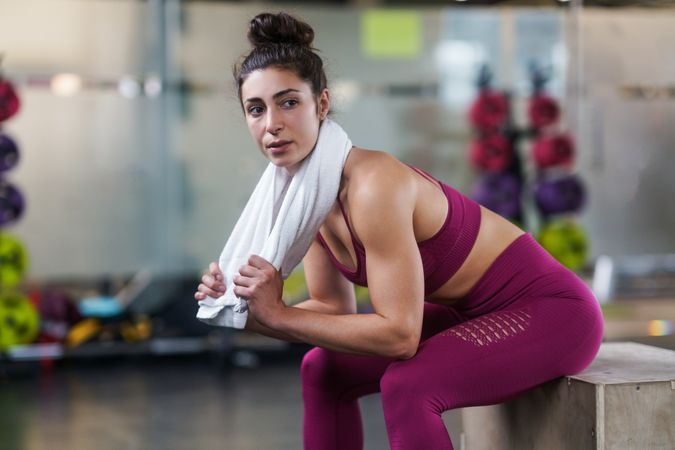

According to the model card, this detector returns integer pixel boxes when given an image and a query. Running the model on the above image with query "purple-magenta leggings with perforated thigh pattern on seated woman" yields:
[301,233,603,450]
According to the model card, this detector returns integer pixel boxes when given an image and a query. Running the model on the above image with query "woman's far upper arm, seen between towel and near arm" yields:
[303,238,356,314]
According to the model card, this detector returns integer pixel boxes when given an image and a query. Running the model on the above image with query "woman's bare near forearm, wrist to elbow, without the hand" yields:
[270,308,418,359]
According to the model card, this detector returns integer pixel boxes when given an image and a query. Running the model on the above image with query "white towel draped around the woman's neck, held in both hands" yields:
[197,119,352,329]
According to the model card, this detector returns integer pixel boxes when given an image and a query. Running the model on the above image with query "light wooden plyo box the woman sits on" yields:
[461,342,675,450]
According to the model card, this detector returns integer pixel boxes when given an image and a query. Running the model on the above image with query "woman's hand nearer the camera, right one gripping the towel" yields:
[232,255,286,328]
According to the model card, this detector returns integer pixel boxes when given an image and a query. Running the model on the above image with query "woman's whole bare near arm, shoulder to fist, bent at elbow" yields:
[240,160,424,359]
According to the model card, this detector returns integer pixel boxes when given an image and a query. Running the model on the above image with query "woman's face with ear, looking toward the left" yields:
[241,67,330,174]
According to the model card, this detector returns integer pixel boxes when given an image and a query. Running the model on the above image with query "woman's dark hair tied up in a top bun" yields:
[233,12,327,106]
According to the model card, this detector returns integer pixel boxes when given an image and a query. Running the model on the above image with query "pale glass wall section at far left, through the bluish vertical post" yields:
[0,1,181,279]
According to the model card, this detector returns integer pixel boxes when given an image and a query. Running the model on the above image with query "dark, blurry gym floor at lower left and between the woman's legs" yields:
[0,355,461,450]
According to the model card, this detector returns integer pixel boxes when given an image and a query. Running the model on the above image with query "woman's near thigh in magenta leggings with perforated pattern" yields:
[387,298,602,410]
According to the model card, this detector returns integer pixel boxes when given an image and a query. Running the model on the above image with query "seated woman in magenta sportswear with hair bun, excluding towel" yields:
[195,13,603,450]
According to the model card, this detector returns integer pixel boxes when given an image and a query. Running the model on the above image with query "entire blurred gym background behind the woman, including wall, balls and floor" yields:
[0,0,675,450]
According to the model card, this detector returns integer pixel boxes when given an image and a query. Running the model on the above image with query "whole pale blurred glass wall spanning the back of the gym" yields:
[0,0,675,278]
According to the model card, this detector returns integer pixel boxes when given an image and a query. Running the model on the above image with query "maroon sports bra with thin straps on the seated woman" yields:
[317,164,480,295]
